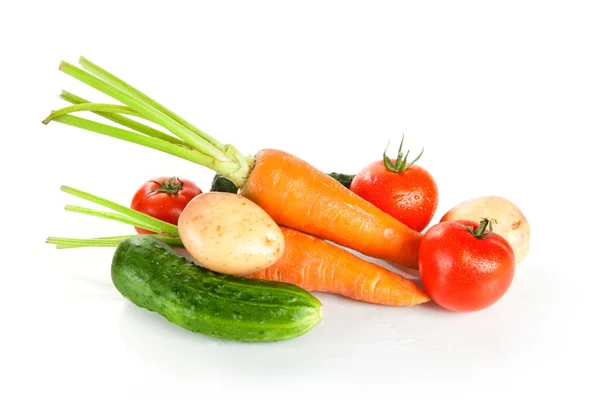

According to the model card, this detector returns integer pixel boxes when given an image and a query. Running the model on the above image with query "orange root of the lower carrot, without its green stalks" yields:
[249,227,430,306]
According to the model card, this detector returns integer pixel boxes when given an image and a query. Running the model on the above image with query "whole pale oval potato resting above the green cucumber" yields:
[178,192,285,275]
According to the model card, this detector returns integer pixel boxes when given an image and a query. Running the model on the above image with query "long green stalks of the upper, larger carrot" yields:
[43,57,254,187]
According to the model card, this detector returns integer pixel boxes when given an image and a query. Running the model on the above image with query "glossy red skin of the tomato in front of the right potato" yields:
[419,221,515,312]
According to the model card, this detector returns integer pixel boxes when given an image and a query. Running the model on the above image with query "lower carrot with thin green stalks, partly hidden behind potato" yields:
[47,186,429,306]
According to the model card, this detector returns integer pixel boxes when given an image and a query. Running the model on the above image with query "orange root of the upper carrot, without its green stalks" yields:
[240,150,423,269]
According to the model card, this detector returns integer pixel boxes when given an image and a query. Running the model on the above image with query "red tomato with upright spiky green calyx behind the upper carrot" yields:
[350,138,438,232]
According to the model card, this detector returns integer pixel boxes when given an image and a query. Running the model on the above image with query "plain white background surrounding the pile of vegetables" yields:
[0,0,600,399]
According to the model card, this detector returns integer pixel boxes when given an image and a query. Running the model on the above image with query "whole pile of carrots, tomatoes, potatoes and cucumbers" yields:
[44,58,530,341]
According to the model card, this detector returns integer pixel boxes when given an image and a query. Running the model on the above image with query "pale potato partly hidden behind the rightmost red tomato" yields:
[441,196,530,264]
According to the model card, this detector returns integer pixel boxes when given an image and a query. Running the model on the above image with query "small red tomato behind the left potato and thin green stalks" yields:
[131,177,202,234]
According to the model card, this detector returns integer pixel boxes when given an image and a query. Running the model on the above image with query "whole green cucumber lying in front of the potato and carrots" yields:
[111,235,322,342]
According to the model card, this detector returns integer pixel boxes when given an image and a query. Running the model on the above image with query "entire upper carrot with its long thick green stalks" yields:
[44,58,423,268]
